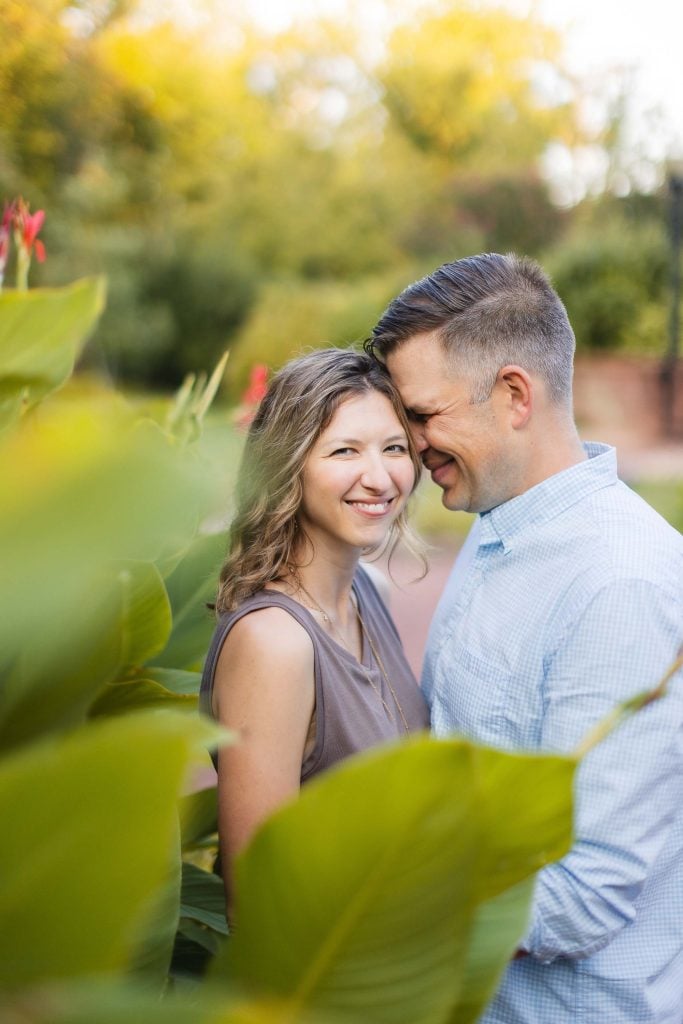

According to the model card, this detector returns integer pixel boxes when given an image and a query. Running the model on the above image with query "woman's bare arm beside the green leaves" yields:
[213,607,315,893]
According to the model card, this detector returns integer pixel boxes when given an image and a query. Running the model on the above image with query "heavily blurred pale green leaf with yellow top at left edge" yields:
[0,395,222,742]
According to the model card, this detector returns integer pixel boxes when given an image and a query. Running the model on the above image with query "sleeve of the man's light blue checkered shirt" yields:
[521,581,683,963]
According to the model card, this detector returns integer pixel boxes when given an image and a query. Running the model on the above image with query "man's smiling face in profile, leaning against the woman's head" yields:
[386,333,516,512]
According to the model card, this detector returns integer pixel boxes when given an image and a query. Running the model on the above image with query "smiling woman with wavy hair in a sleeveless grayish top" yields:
[202,348,428,890]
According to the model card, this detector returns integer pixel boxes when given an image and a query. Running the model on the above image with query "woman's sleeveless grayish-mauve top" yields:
[200,568,429,782]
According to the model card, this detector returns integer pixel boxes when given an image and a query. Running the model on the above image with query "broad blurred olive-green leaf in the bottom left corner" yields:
[0,713,220,988]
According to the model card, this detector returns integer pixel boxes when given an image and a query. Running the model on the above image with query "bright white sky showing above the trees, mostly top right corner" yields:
[244,0,683,167]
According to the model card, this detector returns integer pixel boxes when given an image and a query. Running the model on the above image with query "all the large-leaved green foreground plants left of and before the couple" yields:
[0,262,679,1024]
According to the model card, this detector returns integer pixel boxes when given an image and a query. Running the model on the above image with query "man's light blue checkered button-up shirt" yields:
[423,444,683,1024]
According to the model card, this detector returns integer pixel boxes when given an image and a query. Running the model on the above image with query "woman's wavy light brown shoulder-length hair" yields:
[216,348,422,614]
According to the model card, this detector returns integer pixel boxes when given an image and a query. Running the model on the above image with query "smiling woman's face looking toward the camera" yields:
[299,391,415,555]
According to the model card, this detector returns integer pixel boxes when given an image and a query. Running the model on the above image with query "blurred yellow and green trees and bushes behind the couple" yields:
[0,0,669,399]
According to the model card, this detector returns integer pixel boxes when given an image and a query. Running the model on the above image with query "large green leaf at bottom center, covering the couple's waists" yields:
[212,738,574,1024]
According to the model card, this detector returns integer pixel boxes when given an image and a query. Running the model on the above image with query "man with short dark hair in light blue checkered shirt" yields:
[368,254,683,1024]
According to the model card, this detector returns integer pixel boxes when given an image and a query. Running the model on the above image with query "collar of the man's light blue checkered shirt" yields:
[479,441,617,552]
